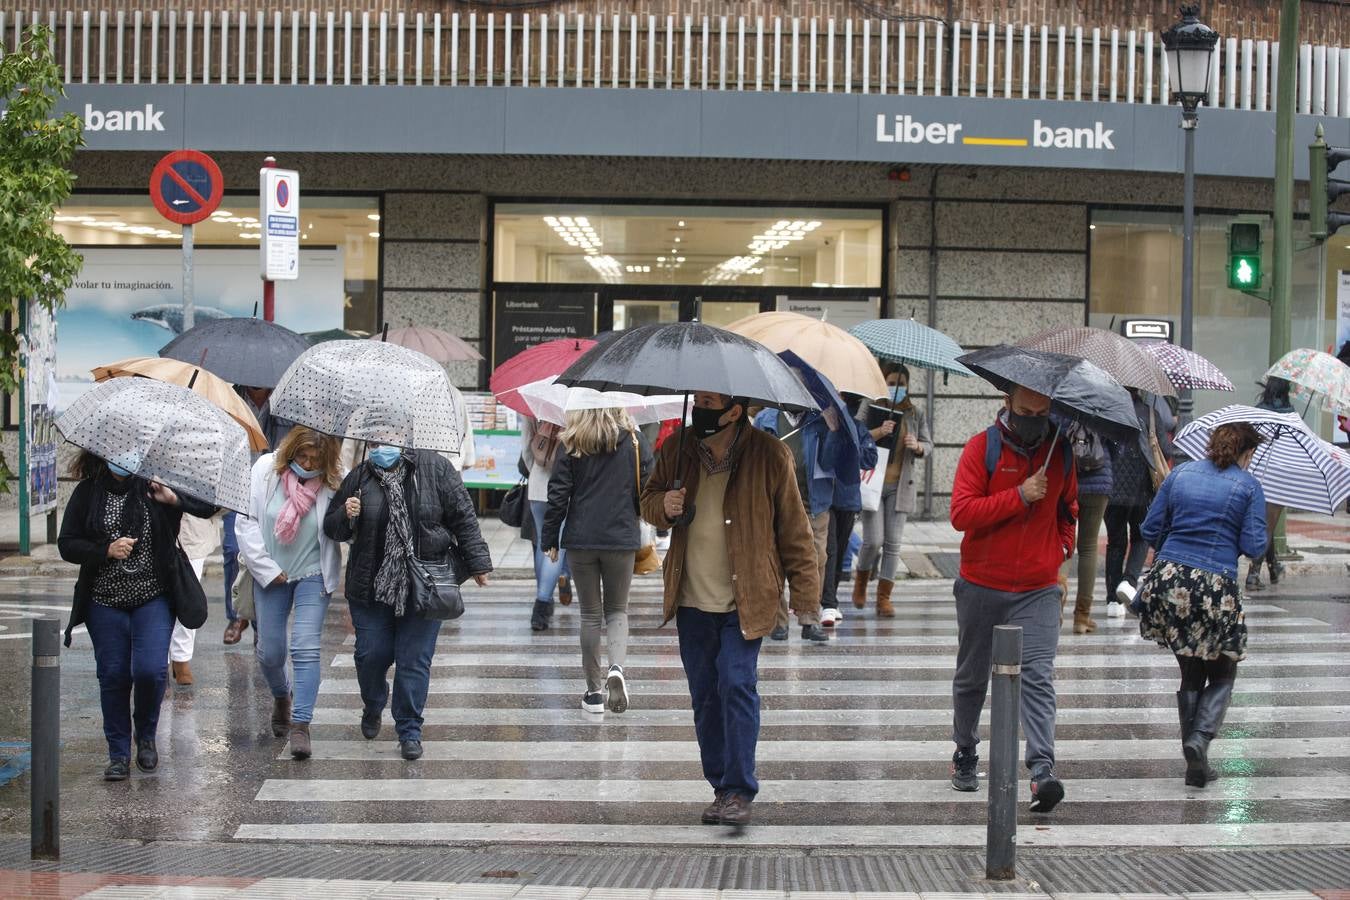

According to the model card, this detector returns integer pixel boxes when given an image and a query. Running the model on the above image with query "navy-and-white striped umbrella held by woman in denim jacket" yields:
[1175,405,1350,515]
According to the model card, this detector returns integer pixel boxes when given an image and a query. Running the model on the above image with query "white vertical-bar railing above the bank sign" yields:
[0,9,1350,117]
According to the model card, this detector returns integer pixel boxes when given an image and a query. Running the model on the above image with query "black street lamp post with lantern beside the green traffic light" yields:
[1162,4,1219,425]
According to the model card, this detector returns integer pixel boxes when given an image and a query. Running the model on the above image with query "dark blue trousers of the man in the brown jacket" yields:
[675,606,761,800]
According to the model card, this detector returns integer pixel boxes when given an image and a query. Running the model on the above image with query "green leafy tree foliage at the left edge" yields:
[0,26,84,490]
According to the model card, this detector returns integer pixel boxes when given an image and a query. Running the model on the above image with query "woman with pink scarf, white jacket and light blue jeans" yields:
[235,425,342,760]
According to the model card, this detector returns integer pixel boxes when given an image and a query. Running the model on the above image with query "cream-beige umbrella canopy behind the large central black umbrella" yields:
[726,313,886,397]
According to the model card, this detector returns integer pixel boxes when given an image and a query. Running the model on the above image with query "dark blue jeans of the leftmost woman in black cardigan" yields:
[85,596,173,760]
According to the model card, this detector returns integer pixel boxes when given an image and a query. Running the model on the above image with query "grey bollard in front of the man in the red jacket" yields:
[984,625,1022,881]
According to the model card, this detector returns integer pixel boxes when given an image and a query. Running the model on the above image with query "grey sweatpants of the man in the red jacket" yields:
[952,579,1060,772]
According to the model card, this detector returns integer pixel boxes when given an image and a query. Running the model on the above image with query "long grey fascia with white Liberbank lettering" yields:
[52,85,1350,178]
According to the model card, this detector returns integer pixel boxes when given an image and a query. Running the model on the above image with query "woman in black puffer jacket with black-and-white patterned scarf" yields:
[324,445,493,760]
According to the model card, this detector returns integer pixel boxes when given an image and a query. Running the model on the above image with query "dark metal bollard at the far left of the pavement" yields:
[30,619,61,860]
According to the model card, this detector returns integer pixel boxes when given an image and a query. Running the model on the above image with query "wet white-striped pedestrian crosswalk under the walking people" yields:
[235,579,1350,847]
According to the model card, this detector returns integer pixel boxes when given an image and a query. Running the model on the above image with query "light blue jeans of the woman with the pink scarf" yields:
[254,575,328,722]
